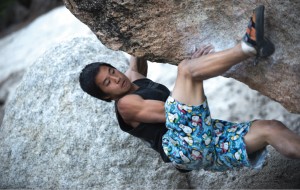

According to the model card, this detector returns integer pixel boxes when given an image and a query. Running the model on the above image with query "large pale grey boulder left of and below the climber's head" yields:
[0,37,187,189]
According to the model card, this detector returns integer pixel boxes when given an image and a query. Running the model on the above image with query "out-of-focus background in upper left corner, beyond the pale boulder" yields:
[0,0,82,126]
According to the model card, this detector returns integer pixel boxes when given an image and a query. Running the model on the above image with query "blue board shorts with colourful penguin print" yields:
[162,96,267,171]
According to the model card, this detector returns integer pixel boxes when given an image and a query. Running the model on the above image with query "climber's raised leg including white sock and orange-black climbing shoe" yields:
[172,4,272,105]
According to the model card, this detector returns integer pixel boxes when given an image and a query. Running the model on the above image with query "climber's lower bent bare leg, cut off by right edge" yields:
[244,120,300,158]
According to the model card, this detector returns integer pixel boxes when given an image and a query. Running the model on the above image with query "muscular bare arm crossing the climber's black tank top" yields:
[118,95,166,126]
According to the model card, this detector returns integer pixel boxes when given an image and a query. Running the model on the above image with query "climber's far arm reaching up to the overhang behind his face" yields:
[125,56,148,82]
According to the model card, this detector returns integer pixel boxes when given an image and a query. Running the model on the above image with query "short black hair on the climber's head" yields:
[79,62,115,102]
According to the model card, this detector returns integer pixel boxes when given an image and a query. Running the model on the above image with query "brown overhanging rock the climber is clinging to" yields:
[64,0,300,113]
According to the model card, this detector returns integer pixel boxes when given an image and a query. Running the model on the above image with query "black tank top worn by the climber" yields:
[115,78,170,162]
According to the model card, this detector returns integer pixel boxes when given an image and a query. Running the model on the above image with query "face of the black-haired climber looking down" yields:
[95,66,132,100]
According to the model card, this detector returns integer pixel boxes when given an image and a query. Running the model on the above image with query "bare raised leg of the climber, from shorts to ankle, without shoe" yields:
[172,44,249,105]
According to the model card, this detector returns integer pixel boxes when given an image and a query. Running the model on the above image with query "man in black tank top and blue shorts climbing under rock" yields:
[80,6,300,171]
